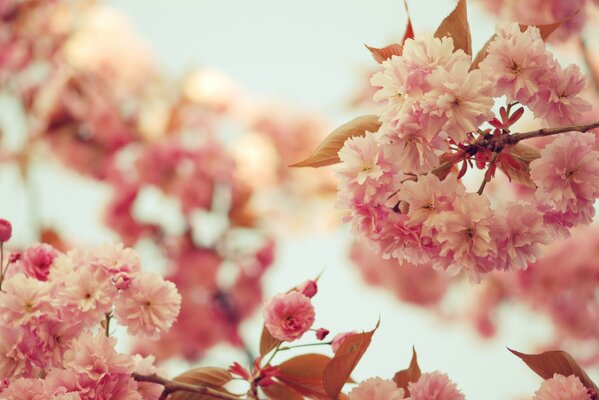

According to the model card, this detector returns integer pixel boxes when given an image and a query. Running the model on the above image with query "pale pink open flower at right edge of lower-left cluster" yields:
[115,272,181,339]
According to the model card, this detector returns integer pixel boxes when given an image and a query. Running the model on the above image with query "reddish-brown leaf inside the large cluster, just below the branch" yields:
[497,143,541,188]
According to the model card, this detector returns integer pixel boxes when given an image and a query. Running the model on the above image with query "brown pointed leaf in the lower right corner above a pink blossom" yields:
[508,348,599,392]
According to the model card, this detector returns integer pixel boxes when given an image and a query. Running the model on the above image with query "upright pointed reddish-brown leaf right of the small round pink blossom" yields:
[322,322,380,399]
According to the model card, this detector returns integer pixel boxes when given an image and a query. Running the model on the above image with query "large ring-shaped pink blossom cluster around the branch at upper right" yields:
[336,24,599,280]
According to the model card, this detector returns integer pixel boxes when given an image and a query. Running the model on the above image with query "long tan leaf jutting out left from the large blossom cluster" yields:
[290,115,381,168]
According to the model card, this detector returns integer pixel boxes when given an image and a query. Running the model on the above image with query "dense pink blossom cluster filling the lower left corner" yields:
[0,227,181,400]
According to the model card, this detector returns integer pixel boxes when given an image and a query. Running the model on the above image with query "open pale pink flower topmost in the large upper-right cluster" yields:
[480,23,555,104]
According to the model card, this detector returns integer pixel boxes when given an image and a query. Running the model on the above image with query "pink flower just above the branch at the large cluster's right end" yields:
[528,65,591,127]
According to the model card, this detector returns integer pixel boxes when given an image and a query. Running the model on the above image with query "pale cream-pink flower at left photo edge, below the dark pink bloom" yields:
[0,273,53,327]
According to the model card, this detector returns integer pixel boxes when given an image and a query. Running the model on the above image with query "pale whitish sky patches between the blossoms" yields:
[0,0,584,400]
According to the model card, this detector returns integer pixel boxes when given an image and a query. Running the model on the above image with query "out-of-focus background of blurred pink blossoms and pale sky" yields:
[0,0,599,400]
